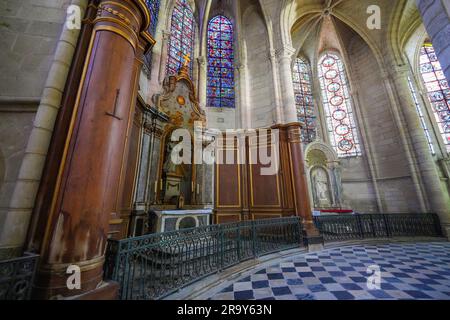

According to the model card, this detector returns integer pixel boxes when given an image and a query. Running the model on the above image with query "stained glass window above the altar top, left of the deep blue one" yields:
[167,0,194,74]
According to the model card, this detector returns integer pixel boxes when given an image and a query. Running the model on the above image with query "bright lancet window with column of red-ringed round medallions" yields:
[319,53,361,157]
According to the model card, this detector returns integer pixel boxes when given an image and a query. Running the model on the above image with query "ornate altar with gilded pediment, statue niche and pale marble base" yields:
[129,56,214,236]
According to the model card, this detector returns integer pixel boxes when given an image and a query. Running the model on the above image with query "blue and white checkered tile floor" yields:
[211,242,450,300]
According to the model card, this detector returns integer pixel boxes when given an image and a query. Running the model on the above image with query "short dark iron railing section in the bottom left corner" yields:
[0,254,39,300]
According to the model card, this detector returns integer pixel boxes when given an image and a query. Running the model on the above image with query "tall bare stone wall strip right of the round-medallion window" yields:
[348,36,420,212]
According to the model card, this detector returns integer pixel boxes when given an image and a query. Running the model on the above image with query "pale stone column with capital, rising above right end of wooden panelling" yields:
[277,46,298,123]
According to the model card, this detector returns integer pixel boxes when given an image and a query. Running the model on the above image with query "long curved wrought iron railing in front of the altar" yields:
[105,217,303,300]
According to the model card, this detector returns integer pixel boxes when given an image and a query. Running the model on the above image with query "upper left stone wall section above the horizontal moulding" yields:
[0,0,70,98]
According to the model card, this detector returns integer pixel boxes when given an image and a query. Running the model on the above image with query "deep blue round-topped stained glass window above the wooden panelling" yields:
[207,15,235,108]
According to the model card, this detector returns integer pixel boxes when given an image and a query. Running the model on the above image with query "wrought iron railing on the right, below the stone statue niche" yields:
[314,213,442,242]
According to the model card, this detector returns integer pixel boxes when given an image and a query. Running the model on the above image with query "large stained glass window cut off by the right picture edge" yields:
[420,42,450,152]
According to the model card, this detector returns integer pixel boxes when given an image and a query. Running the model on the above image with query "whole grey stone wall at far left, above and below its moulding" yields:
[0,0,70,256]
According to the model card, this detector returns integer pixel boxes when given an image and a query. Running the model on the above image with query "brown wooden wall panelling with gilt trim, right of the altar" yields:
[215,129,296,223]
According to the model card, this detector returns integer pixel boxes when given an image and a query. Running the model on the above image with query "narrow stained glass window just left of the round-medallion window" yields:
[292,58,316,143]
